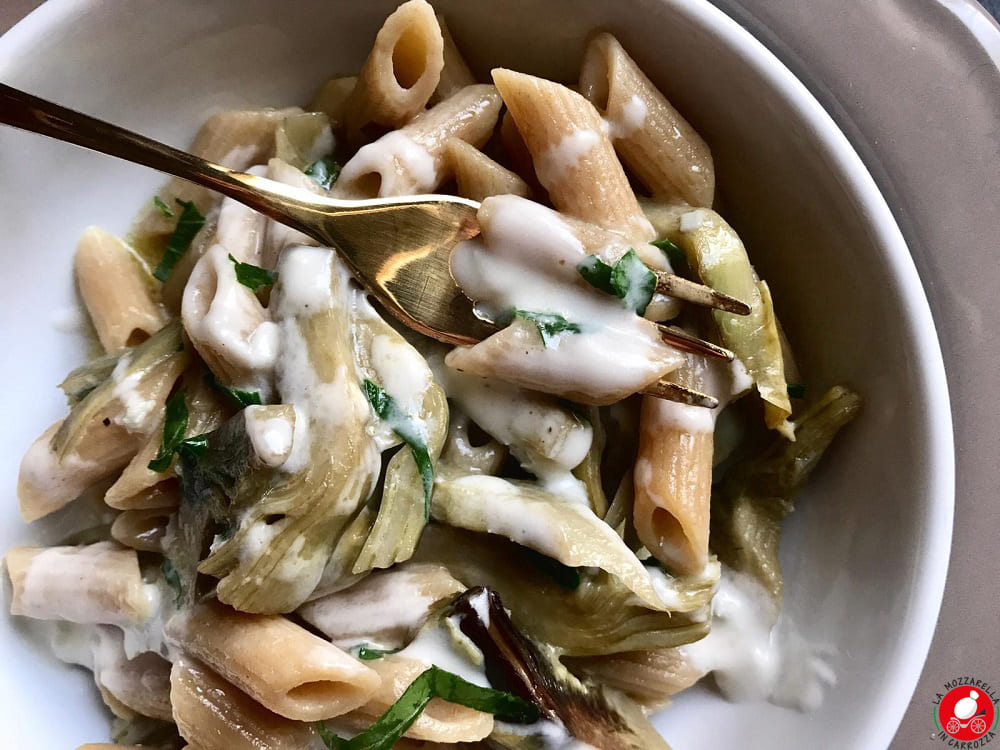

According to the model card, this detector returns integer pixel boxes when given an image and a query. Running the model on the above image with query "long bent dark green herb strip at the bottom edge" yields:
[316,667,540,750]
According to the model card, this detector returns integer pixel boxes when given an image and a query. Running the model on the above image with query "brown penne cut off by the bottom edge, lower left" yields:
[170,654,316,750]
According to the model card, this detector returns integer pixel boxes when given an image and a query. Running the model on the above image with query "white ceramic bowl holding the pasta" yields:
[0,0,954,750]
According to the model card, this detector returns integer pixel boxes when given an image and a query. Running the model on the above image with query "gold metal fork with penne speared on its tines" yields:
[0,84,749,408]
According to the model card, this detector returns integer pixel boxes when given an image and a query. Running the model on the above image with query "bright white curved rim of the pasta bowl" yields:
[0,0,955,748]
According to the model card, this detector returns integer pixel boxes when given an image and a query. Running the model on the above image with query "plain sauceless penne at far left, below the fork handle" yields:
[75,227,167,353]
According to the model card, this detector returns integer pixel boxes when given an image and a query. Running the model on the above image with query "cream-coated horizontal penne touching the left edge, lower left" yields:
[6,542,158,627]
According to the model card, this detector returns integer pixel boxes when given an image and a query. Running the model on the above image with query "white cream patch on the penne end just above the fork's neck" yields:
[335,130,440,198]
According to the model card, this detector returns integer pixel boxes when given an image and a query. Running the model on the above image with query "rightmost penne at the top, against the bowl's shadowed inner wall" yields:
[580,33,715,207]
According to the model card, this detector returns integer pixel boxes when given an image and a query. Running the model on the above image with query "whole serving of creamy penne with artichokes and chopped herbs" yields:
[5,0,860,750]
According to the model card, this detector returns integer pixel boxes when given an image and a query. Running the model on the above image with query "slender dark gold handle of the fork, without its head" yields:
[0,83,302,229]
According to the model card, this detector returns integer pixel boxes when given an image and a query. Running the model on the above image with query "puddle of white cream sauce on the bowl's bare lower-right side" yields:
[681,568,836,711]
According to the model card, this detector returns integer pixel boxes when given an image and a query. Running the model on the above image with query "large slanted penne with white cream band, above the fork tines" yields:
[493,68,654,241]
